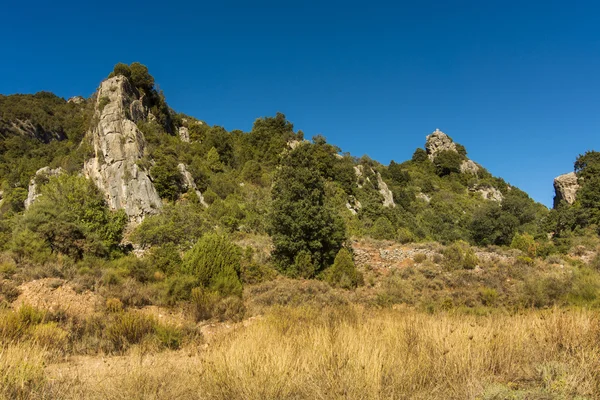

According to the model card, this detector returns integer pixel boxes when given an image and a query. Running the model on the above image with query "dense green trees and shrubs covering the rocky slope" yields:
[0,63,600,314]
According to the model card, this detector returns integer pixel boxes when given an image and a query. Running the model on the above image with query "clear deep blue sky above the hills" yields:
[0,0,600,205]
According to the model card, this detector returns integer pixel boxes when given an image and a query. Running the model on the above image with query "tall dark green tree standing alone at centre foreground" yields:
[269,144,346,278]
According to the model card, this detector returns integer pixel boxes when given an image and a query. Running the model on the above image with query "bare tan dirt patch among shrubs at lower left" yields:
[13,278,103,316]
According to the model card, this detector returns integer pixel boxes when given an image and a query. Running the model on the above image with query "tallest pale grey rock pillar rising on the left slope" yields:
[84,75,162,222]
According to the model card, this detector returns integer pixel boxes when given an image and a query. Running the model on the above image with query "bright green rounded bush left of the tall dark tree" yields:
[183,234,242,296]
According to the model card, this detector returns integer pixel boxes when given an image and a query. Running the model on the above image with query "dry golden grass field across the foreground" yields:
[0,306,600,399]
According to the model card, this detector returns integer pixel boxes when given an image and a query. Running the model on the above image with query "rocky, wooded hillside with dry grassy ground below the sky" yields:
[0,63,600,399]
